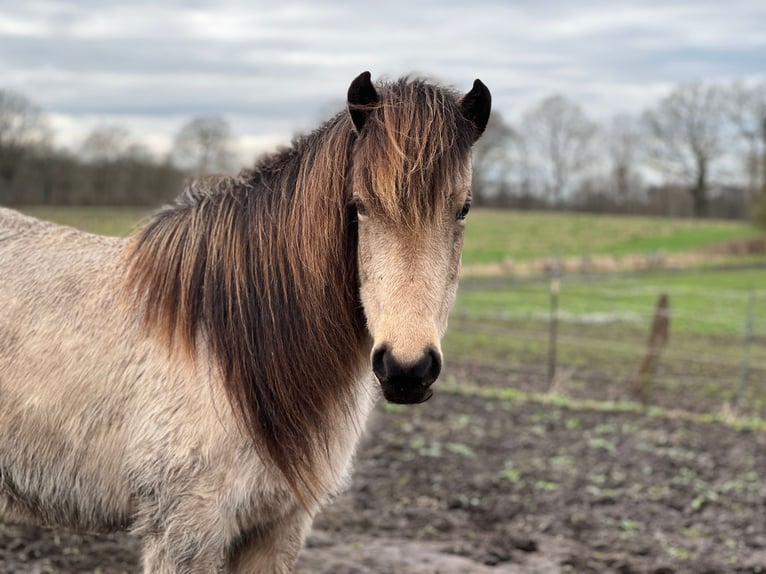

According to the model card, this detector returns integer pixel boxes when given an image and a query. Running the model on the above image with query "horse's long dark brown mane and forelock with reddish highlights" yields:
[126,79,472,504]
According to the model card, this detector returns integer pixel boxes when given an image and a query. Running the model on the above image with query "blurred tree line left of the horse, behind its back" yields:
[0,90,236,210]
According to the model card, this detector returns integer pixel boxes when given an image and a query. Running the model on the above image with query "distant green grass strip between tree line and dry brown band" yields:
[463,209,760,265]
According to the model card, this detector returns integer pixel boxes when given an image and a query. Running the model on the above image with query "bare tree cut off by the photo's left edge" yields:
[0,90,51,190]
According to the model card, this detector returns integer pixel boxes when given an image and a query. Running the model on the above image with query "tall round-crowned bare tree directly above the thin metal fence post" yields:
[522,95,596,204]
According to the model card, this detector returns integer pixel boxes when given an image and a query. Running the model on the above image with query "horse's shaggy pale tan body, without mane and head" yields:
[0,209,374,572]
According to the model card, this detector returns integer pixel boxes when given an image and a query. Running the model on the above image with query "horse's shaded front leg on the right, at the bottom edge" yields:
[229,509,312,574]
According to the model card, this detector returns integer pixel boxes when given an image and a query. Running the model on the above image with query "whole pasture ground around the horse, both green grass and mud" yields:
[6,209,766,574]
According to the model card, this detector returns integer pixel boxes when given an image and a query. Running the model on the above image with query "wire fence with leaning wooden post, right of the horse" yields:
[445,267,766,416]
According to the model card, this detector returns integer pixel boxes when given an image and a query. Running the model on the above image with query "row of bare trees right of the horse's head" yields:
[473,81,766,221]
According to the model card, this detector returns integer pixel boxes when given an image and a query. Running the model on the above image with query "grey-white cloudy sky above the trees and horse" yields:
[0,0,766,162]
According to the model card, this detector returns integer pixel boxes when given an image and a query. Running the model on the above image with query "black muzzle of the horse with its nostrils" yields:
[372,345,442,404]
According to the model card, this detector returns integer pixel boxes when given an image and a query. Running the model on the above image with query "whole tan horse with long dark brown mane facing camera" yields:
[0,72,491,574]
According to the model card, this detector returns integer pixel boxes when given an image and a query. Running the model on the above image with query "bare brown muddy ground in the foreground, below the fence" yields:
[0,369,766,574]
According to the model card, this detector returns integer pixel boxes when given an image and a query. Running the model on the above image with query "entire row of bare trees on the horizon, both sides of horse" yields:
[0,77,766,221]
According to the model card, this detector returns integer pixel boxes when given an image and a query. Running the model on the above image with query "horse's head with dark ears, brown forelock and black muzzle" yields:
[348,72,491,403]
